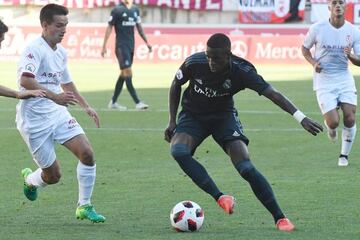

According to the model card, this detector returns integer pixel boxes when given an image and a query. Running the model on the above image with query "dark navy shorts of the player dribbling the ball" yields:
[175,110,249,151]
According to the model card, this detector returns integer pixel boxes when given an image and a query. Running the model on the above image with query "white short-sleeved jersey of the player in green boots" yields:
[16,37,72,133]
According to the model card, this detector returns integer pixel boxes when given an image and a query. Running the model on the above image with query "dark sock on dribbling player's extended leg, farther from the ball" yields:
[235,160,285,223]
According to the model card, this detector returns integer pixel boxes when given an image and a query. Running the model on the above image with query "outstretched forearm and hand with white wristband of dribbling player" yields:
[262,85,323,136]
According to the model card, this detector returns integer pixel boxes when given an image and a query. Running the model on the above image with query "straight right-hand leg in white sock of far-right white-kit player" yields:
[338,103,356,166]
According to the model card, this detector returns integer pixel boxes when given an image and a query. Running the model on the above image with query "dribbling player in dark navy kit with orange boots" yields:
[164,33,323,231]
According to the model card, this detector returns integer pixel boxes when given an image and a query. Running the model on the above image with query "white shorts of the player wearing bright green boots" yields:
[19,112,84,169]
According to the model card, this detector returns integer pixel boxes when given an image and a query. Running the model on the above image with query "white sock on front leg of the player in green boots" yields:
[76,161,96,206]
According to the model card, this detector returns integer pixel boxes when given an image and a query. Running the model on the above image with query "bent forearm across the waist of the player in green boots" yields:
[20,74,77,106]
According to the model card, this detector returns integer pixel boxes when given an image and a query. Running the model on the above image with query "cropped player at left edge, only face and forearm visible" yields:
[0,20,45,99]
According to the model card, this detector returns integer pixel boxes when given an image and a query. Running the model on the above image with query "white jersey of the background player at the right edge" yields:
[303,20,360,90]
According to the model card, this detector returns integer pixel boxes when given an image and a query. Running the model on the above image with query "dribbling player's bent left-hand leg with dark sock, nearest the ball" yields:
[170,112,223,205]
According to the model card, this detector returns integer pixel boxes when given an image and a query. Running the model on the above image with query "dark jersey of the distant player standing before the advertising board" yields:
[108,3,141,50]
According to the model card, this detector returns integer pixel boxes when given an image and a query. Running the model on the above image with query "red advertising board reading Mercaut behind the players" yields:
[0,26,305,64]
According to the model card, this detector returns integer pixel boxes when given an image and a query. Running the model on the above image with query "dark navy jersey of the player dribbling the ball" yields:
[175,52,269,114]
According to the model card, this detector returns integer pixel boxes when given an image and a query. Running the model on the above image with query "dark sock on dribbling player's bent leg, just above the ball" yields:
[171,144,223,200]
